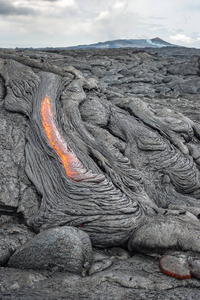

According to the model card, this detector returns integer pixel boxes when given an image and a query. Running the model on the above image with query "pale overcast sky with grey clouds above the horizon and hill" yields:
[0,0,200,48]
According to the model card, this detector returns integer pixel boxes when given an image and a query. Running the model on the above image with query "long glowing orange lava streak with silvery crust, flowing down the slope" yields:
[41,97,92,181]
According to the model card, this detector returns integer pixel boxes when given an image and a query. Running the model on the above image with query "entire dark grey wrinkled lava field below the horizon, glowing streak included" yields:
[0,47,200,299]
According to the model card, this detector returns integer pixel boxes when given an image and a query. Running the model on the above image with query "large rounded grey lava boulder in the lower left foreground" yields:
[8,226,93,274]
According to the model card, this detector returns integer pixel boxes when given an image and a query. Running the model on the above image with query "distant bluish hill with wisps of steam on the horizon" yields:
[35,37,177,50]
